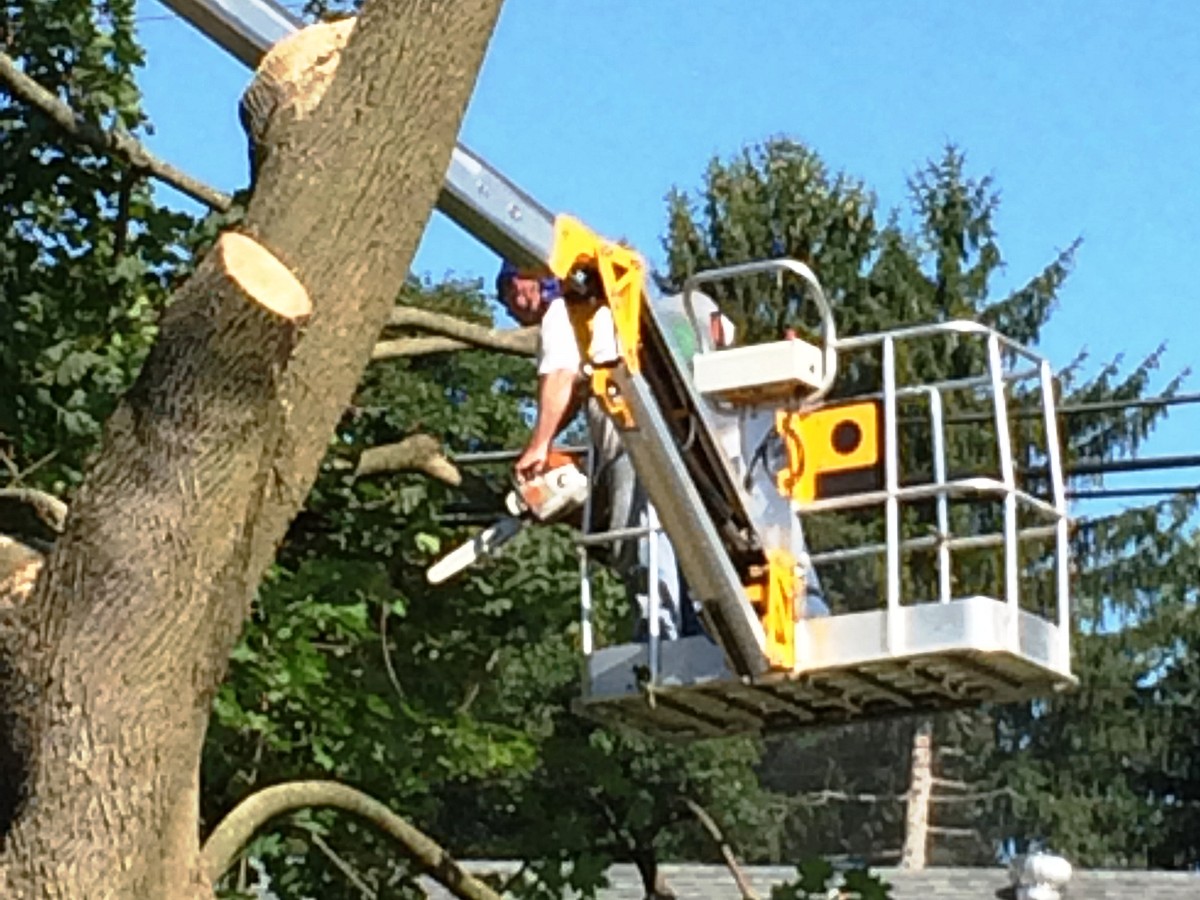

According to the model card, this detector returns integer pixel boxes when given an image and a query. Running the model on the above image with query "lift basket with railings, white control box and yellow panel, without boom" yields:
[578,267,1075,738]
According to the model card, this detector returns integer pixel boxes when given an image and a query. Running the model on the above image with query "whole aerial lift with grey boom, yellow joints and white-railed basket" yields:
[157,0,1074,739]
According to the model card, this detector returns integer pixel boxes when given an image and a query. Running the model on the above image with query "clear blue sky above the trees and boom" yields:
[139,0,1200,504]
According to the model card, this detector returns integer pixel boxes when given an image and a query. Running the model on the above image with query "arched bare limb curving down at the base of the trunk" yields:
[200,781,500,900]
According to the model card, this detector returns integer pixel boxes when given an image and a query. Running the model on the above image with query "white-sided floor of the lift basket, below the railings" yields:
[578,596,1074,739]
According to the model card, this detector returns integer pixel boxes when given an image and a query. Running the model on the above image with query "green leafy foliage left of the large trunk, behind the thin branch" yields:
[0,0,190,491]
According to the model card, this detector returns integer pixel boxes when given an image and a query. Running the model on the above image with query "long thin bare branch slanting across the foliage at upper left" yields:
[0,53,233,212]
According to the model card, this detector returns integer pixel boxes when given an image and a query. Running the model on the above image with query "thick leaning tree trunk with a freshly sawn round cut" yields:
[0,0,499,900]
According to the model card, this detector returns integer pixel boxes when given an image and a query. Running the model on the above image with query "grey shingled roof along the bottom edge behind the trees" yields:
[415,862,1200,900]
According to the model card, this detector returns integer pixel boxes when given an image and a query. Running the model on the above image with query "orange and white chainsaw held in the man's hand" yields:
[425,451,588,584]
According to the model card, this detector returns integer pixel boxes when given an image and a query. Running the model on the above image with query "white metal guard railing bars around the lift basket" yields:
[578,322,1070,684]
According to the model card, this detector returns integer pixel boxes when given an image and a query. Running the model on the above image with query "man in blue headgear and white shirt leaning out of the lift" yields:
[496,262,698,640]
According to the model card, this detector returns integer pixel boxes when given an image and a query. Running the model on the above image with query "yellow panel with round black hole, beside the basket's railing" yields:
[775,400,880,503]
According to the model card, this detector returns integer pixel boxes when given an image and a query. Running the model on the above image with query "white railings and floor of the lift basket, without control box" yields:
[578,322,1074,738]
